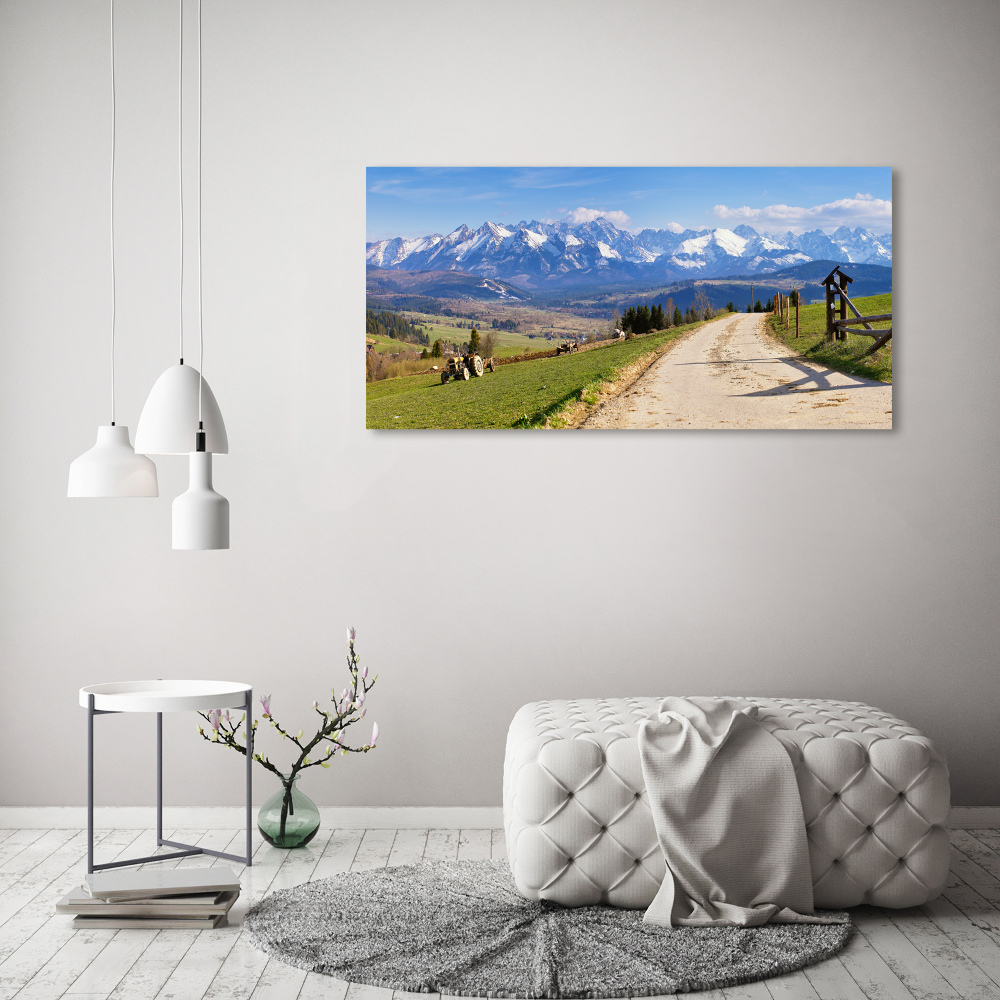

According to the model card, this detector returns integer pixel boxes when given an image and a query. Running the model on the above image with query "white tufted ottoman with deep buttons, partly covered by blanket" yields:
[503,698,950,909]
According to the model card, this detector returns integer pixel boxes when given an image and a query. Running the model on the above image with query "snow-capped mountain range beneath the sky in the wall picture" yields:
[365,218,892,288]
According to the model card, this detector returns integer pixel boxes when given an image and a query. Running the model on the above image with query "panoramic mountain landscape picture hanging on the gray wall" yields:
[365,167,892,430]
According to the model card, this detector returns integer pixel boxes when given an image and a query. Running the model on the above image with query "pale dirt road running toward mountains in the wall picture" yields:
[582,313,892,429]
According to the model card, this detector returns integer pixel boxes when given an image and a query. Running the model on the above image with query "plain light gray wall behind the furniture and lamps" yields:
[0,0,1000,805]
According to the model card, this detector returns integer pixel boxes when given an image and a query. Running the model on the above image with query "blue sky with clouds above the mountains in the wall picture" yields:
[367,167,892,241]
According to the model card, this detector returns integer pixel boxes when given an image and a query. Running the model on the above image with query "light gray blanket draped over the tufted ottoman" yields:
[639,698,839,927]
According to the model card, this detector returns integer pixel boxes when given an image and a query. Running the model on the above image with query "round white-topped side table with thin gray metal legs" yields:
[80,680,253,873]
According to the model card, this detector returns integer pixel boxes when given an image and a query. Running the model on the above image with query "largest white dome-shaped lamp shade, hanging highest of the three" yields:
[135,365,229,455]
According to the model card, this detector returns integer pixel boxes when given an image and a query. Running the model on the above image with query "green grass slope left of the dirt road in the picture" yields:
[366,326,691,428]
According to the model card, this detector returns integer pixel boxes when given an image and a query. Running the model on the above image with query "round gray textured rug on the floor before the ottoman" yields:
[244,861,851,997]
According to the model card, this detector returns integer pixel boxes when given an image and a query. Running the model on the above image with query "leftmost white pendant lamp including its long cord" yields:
[66,0,158,497]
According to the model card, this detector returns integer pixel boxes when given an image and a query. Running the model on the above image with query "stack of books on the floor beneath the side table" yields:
[56,867,240,928]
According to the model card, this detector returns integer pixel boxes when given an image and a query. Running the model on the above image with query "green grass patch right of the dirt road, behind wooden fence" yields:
[767,292,892,382]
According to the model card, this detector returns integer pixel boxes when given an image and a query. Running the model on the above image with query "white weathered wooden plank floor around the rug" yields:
[0,830,1000,1000]
